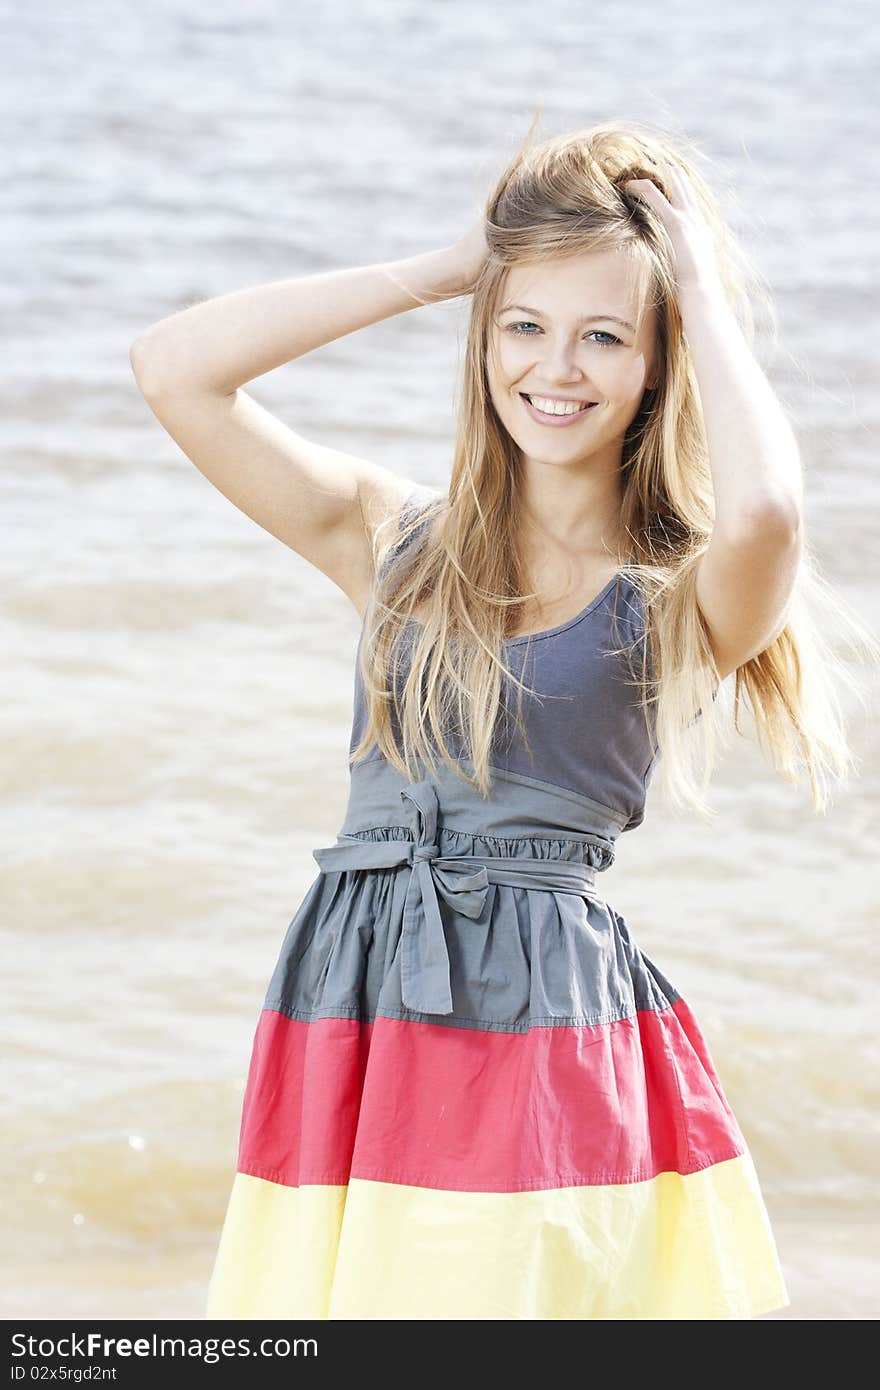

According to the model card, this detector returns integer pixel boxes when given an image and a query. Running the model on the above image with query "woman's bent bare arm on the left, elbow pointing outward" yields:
[131,232,480,614]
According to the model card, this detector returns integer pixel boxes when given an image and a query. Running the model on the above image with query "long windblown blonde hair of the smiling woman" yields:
[352,121,880,816]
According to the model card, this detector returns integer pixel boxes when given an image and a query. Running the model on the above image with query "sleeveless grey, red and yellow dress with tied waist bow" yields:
[206,499,790,1319]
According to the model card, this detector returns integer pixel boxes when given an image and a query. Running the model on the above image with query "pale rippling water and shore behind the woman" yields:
[0,0,880,1319]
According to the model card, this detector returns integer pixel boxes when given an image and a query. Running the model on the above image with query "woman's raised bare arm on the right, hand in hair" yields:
[626,164,804,680]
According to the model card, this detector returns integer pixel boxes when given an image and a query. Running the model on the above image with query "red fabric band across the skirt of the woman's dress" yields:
[238,998,745,1193]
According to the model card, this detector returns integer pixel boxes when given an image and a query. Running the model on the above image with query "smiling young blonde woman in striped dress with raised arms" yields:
[132,122,867,1319]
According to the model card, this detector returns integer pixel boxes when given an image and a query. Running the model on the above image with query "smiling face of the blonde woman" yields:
[487,250,656,463]
